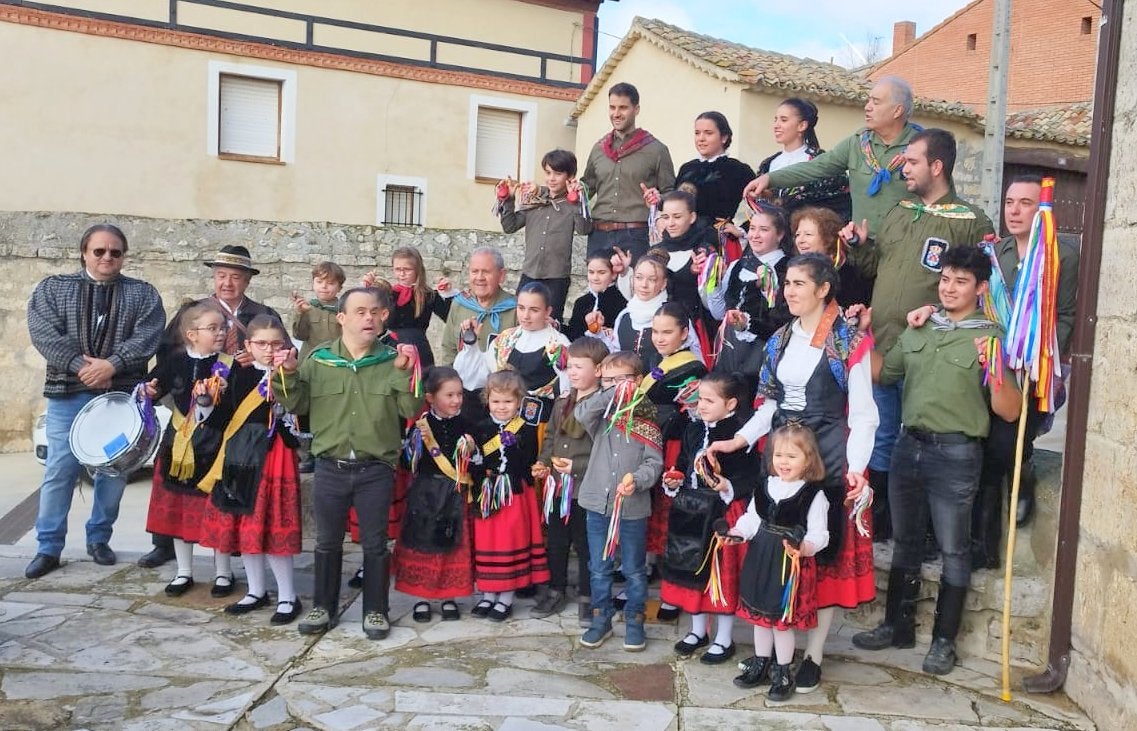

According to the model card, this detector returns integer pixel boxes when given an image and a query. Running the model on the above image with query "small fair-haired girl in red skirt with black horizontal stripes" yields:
[471,371,549,622]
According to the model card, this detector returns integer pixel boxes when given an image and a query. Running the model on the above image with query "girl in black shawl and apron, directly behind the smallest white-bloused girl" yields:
[659,373,762,665]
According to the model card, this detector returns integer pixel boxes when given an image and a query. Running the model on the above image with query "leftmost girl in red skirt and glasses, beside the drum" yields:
[146,305,234,597]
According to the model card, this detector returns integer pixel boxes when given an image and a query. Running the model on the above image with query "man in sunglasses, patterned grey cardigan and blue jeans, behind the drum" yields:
[24,224,166,579]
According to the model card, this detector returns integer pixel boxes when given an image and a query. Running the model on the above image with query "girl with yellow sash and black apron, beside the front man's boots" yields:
[395,366,476,622]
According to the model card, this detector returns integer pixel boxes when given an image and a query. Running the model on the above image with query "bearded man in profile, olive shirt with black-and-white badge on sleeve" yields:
[869,128,994,539]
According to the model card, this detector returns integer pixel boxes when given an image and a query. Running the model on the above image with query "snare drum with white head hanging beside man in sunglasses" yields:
[68,391,161,477]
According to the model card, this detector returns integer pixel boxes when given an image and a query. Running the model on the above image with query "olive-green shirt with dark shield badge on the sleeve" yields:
[872,192,994,354]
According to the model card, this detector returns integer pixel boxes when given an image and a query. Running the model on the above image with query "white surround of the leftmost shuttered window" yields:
[206,61,297,165]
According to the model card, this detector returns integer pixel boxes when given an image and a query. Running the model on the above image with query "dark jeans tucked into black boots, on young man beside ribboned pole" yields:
[888,431,984,587]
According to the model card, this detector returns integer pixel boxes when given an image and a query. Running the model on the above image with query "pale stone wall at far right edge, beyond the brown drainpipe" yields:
[1067,2,1137,729]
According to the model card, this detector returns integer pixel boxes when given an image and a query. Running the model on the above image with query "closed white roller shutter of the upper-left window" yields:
[217,74,281,159]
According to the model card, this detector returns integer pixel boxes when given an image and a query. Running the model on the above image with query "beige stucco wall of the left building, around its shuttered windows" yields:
[0,23,574,230]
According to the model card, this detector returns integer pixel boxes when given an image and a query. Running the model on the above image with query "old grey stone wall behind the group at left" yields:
[0,213,584,451]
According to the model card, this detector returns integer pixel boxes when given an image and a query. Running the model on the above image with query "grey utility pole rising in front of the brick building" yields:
[980,0,1011,231]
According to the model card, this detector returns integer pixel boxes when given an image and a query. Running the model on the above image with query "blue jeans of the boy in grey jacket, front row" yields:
[584,510,647,621]
